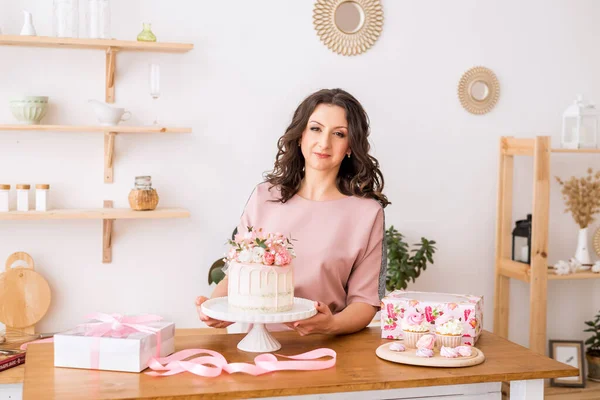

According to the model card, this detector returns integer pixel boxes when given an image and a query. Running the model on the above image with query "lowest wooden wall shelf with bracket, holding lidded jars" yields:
[0,200,190,263]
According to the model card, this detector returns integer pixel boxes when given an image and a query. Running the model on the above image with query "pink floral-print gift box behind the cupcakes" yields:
[381,290,483,346]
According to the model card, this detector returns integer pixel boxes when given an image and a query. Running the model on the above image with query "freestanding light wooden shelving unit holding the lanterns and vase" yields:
[494,136,600,354]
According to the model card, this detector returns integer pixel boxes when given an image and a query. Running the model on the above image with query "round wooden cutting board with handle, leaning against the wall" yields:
[0,252,51,329]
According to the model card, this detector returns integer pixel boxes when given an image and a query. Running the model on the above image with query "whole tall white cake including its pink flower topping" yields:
[225,227,296,313]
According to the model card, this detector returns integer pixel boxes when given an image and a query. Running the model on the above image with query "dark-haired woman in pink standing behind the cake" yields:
[196,89,390,336]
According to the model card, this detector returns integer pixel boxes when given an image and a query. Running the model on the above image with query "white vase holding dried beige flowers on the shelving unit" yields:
[556,168,600,266]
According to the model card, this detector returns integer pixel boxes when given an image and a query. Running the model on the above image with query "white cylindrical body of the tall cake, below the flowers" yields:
[227,262,294,313]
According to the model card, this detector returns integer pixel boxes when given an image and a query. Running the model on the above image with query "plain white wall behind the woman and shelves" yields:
[0,0,600,354]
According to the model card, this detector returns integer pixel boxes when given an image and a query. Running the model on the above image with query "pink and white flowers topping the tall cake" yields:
[223,226,296,267]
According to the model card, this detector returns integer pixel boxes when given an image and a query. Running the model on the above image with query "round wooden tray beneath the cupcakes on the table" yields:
[375,342,485,368]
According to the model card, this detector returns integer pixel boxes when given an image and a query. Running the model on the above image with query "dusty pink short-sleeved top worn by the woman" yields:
[232,182,387,314]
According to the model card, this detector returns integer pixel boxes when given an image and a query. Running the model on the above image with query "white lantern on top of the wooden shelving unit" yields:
[561,95,599,149]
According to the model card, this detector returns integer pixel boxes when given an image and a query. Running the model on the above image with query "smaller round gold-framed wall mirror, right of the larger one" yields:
[458,67,500,114]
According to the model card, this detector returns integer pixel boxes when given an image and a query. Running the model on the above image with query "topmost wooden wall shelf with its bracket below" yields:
[0,35,194,103]
